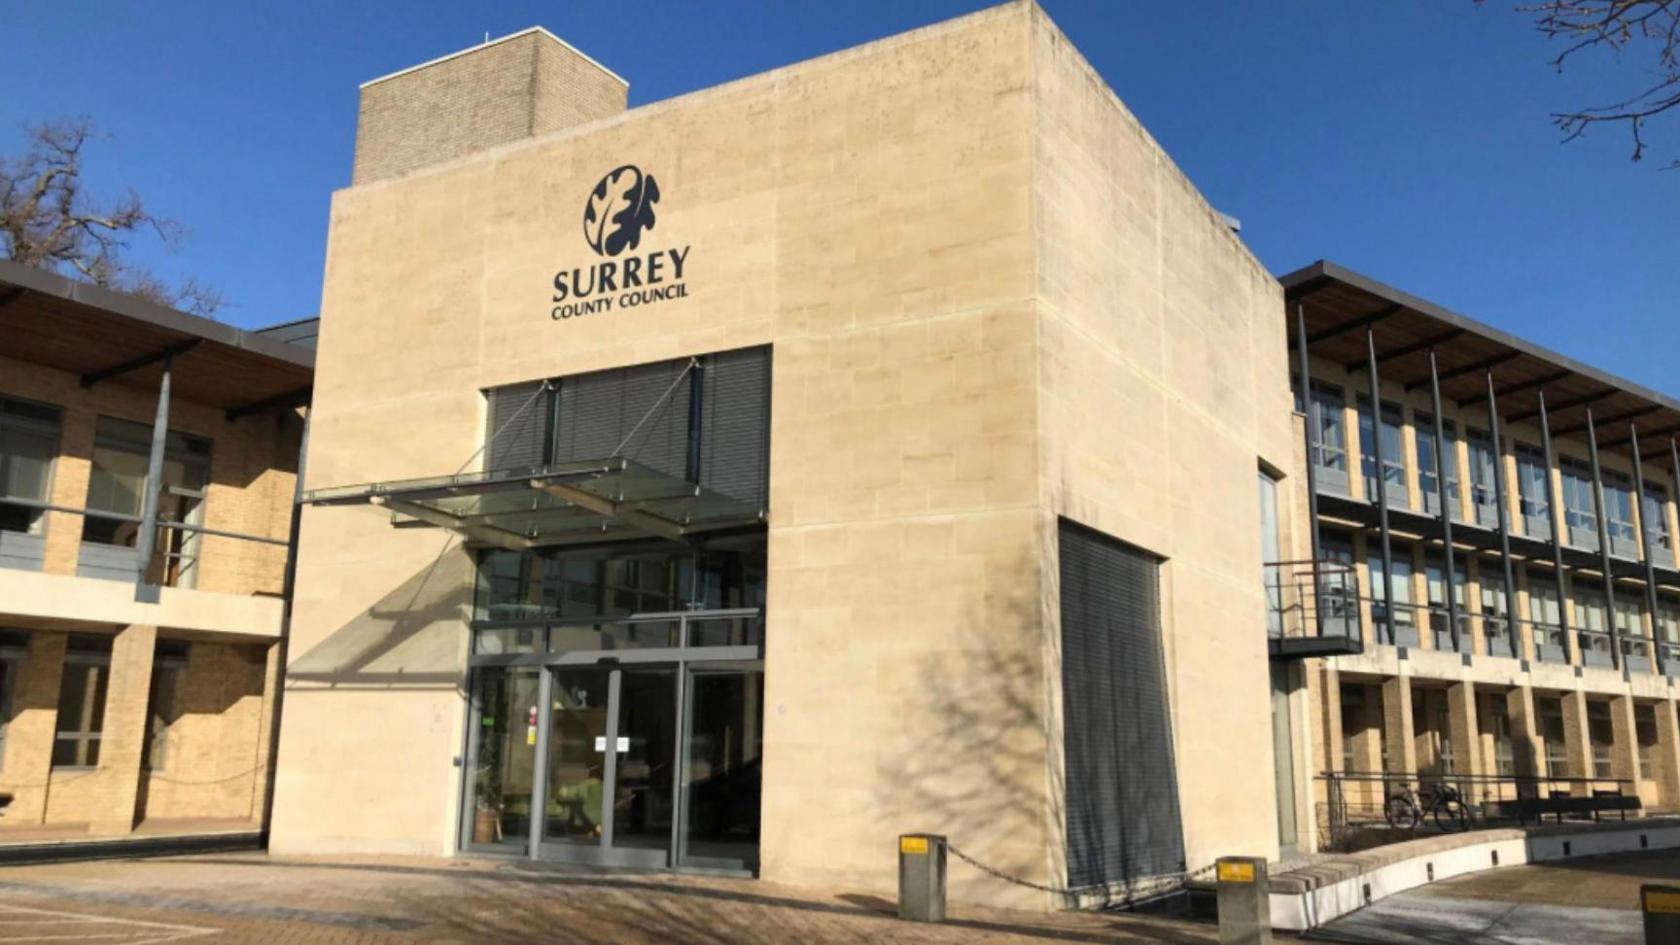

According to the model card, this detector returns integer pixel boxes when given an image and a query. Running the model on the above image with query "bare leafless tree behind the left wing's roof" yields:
[0,119,222,316]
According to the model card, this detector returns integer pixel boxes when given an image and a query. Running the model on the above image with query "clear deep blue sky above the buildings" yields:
[0,0,1680,393]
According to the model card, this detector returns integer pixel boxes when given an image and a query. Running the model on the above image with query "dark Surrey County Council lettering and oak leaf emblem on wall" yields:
[549,165,689,321]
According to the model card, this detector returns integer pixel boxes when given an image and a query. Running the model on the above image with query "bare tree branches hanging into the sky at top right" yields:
[1512,0,1680,166]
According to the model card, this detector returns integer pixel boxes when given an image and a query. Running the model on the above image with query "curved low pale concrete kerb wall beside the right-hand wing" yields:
[1270,817,1680,932]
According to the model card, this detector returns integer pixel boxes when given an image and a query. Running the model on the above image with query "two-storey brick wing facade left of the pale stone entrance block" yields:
[0,264,309,842]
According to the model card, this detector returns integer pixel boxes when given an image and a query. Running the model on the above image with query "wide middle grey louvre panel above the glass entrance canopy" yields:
[553,358,689,476]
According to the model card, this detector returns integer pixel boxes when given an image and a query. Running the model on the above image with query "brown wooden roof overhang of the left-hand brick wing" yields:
[0,261,314,417]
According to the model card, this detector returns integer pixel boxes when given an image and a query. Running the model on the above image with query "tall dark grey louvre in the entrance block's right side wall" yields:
[1058,520,1184,890]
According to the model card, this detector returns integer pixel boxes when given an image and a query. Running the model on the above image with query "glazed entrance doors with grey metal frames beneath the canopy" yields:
[462,614,764,871]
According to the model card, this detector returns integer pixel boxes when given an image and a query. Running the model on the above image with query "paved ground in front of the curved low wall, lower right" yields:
[1310,851,1680,945]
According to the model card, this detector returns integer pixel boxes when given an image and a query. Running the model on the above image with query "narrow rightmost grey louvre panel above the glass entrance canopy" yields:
[701,348,769,506]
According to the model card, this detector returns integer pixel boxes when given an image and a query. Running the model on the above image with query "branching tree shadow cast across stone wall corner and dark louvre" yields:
[877,548,1183,914]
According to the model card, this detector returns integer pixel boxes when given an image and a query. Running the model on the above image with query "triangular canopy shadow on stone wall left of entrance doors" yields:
[286,524,472,688]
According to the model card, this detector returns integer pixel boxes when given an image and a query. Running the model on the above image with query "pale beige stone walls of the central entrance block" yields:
[272,3,1292,906]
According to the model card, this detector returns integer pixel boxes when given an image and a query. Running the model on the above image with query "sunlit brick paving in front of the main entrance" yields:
[0,854,1218,945]
